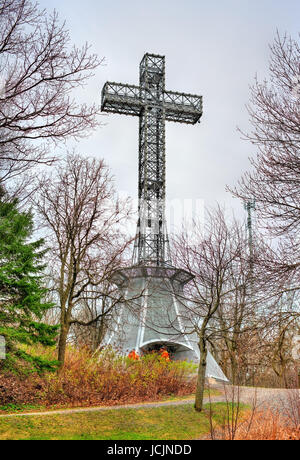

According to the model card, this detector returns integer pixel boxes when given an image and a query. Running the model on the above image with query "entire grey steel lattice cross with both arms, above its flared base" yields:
[101,53,202,266]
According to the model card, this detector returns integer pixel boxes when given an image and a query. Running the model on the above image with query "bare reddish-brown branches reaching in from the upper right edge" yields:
[233,33,300,280]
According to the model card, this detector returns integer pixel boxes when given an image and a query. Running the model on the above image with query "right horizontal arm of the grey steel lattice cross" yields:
[164,91,202,124]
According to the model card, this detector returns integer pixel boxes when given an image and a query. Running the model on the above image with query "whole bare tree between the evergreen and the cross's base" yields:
[35,154,129,366]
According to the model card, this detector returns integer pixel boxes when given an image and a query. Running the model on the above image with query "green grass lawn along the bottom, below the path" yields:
[0,403,245,440]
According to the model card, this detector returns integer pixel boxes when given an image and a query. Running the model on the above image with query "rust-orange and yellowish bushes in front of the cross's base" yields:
[0,347,195,406]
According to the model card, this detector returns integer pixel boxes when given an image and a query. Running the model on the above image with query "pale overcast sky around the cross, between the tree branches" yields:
[39,0,300,230]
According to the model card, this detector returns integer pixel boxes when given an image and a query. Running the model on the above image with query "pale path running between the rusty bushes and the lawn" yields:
[0,386,300,418]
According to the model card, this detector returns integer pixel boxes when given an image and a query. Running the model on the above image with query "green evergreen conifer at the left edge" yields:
[0,193,57,370]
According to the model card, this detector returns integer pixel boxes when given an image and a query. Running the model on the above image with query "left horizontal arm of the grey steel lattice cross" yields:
[101,81,143,116]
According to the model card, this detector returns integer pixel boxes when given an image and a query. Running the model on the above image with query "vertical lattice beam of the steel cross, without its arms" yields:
[138,54,166,265]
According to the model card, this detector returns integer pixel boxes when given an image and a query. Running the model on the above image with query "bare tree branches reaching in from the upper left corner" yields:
[0,0,100,192]
